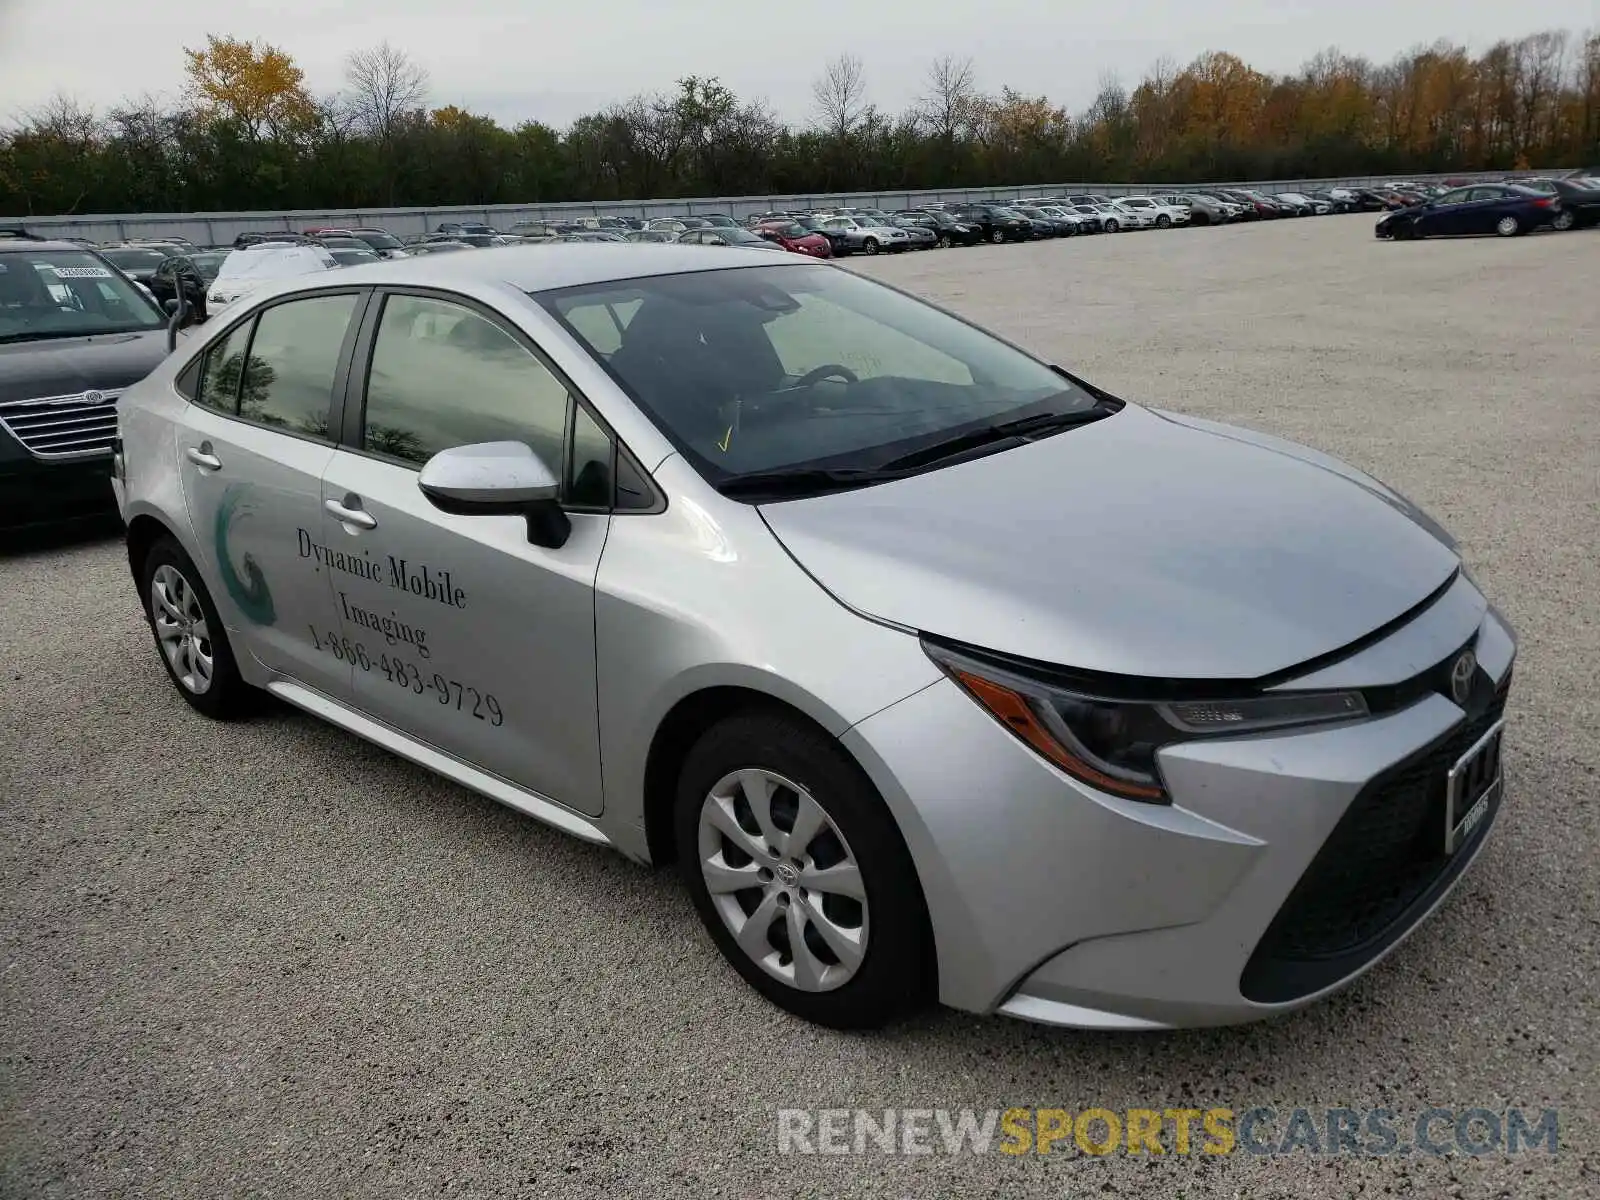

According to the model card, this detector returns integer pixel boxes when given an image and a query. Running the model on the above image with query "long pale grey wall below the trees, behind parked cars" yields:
[9,173,1536,246]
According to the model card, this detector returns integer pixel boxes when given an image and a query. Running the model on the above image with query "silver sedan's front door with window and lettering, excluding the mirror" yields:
[323,293,610,814]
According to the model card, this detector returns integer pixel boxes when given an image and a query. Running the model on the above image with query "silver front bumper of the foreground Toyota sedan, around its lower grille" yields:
[845,581,1515,1029]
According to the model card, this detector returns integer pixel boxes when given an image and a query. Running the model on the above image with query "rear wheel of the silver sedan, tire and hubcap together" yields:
[139,536,258,720]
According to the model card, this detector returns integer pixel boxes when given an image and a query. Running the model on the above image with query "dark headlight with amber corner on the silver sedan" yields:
[922,640,1368,803]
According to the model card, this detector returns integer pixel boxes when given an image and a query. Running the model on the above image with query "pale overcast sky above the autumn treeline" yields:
[0,0,1600,126]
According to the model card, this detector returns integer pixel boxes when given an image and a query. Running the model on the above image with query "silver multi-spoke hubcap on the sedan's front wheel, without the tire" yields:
[699,768,869,992]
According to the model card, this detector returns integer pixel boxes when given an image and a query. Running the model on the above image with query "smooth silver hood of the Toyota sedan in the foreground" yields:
[762,405,1459,680]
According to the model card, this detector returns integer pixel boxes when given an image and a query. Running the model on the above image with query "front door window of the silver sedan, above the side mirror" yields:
[362,296,568,469]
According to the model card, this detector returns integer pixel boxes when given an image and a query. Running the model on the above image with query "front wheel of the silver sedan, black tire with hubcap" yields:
[675,712,933,1029]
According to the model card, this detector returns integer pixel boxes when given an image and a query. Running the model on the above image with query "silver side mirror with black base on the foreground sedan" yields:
[416,442,573,549]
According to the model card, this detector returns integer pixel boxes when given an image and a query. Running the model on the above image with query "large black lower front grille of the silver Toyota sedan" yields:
[1240,675,1510,1003]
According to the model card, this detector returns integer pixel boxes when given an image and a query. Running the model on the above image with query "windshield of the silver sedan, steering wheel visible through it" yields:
[534,266,1096,485]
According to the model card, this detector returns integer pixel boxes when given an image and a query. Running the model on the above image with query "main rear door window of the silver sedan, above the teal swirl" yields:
[238,294,357,438]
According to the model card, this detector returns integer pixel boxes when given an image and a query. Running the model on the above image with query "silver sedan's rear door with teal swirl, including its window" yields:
[174,291,360,699]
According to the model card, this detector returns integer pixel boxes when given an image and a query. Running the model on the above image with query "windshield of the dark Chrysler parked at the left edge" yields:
[0,250,166,342]
